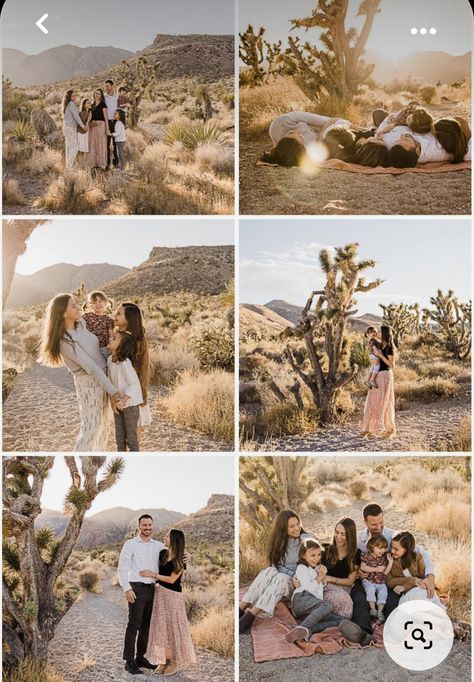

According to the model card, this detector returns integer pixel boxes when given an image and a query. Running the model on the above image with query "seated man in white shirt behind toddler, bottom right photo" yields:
[351,503,435,633]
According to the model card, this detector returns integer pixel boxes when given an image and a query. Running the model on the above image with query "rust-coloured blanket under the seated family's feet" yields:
[250,602,383,663]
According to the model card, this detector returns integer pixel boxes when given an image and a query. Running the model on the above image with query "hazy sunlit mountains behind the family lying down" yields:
[364,50,471,84]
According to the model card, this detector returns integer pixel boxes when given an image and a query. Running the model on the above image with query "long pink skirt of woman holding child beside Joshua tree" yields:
[362,369,395,436]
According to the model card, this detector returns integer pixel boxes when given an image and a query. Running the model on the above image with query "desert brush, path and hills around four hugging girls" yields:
[3,221,234,452]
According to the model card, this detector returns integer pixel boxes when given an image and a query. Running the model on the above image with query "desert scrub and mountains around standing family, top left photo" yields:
[2,34,234,215]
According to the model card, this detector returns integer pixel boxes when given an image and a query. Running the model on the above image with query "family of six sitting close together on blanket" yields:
[239,503,468,646]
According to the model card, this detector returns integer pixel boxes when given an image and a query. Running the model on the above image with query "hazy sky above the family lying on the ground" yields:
[239,0,472,59]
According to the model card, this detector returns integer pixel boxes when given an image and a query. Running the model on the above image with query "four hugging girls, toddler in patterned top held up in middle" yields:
[39,291,151,452]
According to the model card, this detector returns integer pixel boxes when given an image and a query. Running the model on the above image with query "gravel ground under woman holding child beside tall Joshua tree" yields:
[257,387,471,452]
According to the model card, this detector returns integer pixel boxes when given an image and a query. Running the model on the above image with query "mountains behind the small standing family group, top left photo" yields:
[3,34,234,90]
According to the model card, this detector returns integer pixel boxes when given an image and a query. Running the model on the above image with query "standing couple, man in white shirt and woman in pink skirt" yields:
[117,514,196,676]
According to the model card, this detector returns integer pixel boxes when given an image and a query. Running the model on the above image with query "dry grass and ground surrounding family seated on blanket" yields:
[239,456,471,682]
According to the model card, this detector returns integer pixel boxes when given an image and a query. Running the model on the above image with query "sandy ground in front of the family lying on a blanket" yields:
[240,137,471,215]
